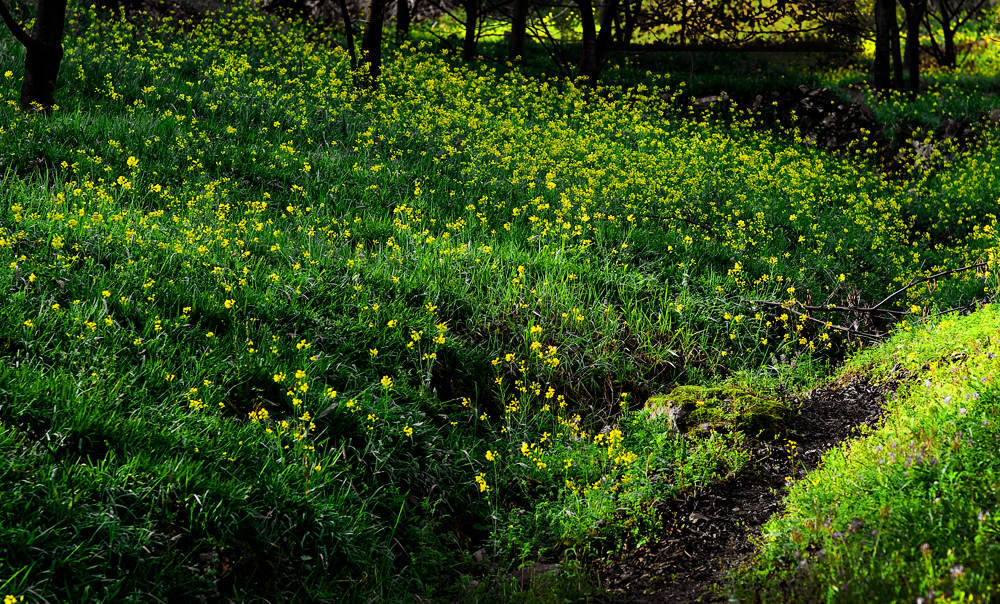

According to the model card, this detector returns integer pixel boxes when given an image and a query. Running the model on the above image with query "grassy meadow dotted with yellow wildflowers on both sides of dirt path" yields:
[0,4,1000,602]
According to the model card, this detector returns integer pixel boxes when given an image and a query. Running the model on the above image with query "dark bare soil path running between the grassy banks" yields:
[598,376,895,602]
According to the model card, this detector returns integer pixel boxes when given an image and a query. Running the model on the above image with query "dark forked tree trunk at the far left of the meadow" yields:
[0,0,66,112]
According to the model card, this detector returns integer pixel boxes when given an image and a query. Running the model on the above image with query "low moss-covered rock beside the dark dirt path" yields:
[646,386,786,432]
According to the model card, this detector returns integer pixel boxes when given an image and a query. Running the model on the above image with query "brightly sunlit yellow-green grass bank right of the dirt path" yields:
[742,306,1000,602]
